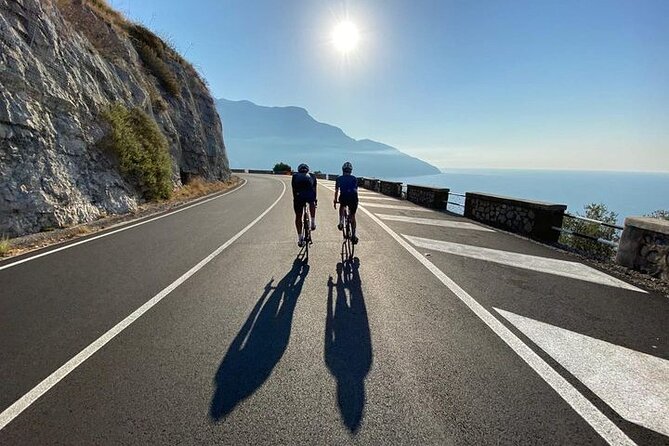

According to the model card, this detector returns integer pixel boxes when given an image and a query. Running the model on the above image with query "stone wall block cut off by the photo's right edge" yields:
[616,217,669,283]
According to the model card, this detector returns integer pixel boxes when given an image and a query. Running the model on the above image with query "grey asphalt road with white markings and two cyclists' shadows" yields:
[0,175,669,445]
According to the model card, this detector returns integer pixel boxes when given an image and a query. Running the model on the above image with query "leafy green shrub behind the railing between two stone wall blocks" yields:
[560,203,620,259]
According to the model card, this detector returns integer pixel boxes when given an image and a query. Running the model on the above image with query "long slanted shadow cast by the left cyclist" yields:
[209,256,309,420]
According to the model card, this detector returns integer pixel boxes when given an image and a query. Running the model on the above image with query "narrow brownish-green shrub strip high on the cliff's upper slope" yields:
[127,24,181,96]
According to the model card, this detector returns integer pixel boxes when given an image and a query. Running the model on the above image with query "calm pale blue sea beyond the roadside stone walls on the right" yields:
[388,169,669,224]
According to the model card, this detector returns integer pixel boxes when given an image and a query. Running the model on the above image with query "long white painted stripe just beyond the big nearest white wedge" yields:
[402,234,646,293]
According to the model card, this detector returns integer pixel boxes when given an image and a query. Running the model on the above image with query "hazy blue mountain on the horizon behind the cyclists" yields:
[216,99,439,178]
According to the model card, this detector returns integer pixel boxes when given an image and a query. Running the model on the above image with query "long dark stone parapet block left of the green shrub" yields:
[465,192,567,243]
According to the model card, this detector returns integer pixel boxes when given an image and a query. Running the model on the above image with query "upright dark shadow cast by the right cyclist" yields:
[323,257,372,434]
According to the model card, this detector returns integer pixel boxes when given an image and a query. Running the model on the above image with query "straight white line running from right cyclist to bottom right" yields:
[360,207,636,445]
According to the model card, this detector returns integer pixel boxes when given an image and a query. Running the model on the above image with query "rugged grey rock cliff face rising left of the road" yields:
[0,0,230,236]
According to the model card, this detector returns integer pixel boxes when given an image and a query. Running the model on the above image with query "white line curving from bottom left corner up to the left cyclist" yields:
[0,181,286,430]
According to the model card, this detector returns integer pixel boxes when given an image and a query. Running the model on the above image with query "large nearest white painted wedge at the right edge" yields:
[495,308,669,436]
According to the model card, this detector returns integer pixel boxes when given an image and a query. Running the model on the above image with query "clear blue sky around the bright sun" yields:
[117,0,669,171]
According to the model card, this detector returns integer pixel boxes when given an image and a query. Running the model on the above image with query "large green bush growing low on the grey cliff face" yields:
[103,104,172,200]
